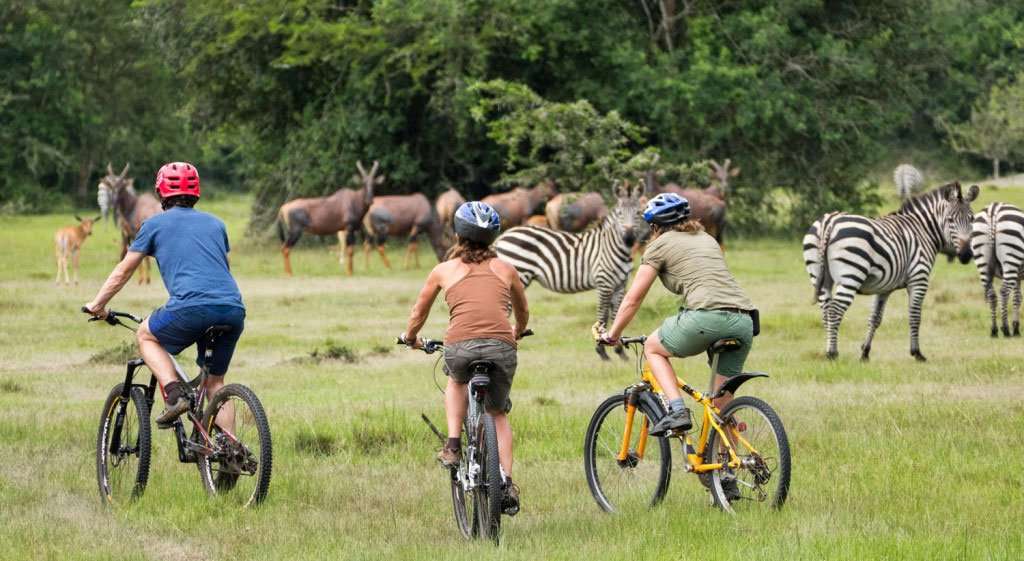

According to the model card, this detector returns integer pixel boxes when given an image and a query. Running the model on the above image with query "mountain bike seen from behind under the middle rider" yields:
[396,330,534,544]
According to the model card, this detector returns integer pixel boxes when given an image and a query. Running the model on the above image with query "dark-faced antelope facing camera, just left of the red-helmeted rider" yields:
[96,163,164,285]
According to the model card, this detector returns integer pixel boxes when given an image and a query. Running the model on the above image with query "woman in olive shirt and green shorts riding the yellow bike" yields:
[601,193,754,436]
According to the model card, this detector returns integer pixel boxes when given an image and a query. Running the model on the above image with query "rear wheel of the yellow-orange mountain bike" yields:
[705,395,790,512]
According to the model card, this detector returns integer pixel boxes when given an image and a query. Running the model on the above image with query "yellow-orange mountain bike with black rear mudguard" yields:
[584,337,790,513]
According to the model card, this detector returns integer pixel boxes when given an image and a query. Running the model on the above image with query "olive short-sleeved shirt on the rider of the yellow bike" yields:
[641,230,754,310]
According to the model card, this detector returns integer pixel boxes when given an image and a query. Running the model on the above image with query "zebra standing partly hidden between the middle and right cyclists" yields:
[495,185,643,360]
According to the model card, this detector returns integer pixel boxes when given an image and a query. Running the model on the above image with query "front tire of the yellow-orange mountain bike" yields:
[584,393,672,513]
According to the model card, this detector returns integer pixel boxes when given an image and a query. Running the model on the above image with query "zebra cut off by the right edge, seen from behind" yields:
[971,203,1024,337]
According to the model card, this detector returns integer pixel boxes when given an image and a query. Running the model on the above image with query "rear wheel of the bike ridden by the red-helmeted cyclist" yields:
[198,384,273,507]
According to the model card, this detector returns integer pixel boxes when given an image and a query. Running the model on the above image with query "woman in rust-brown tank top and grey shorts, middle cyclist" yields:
[401,202,529,514]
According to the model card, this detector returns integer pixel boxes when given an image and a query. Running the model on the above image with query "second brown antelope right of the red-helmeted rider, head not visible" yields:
[362,192,447,269]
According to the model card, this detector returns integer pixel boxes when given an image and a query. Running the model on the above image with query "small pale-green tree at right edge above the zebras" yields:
[940,74,1024,179]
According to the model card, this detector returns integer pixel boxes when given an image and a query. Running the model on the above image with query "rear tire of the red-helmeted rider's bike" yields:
[196,384,273,508]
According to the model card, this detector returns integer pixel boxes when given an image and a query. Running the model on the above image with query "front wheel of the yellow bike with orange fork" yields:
[583,394,672,513]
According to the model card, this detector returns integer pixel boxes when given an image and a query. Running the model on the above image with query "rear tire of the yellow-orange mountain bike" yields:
[705,395,792,513]
